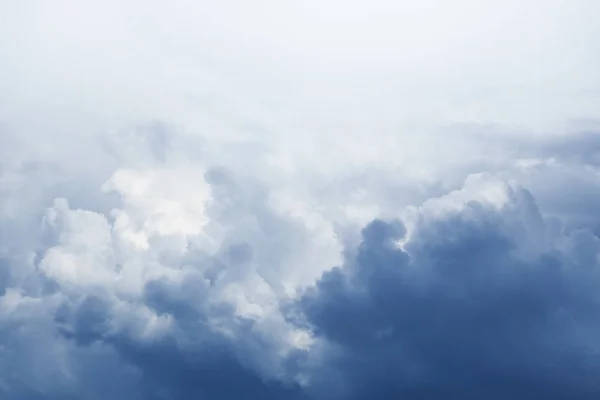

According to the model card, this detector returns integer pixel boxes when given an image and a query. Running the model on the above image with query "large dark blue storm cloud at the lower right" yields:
[298,188,600,400]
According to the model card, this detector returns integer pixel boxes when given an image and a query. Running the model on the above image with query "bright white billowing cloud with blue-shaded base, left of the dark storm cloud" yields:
[1,152,339,399]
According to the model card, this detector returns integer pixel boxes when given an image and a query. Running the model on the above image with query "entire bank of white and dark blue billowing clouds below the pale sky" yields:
[0,145,600,400]
